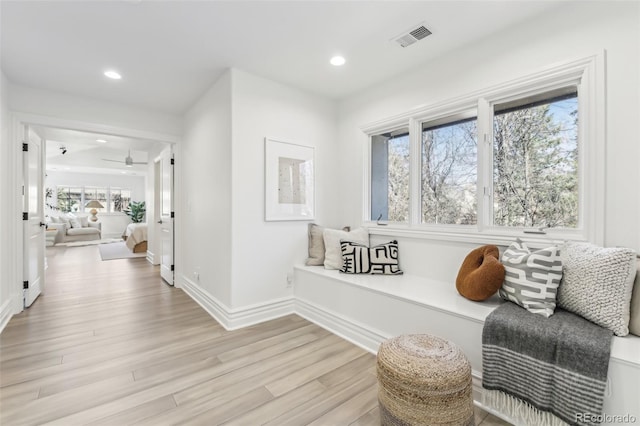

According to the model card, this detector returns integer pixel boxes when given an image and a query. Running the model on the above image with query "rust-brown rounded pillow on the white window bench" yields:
[456,245,504,302]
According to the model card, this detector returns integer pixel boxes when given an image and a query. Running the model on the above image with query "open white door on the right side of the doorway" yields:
[158,148,174,285]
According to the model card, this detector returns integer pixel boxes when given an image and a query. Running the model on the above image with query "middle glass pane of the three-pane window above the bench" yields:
[421,117,478,225]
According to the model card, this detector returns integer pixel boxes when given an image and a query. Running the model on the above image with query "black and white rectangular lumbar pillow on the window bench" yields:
[340,240,402,275]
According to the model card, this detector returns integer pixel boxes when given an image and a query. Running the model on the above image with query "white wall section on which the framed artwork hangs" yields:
[232,69,344,308]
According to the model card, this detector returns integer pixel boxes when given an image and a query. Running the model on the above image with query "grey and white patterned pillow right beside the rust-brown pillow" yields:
[499,239,562,318]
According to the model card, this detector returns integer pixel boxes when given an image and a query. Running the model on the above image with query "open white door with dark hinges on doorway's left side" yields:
[22,125,45,308]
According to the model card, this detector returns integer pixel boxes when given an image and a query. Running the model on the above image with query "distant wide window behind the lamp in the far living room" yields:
[56,186,131,213]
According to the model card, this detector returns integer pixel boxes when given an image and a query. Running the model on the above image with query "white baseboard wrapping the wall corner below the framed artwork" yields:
[177,275,294,330]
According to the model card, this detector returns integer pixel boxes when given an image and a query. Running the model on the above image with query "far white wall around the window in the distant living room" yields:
[44,170,146,238]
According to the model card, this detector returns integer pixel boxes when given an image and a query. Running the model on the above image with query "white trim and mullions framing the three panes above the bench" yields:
[360,51,606,245]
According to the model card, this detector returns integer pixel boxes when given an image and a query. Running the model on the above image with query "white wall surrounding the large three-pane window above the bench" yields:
[339,2,640,280]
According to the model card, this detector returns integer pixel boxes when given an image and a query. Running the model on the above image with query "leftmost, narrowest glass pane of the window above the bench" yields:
[371,129,409,222]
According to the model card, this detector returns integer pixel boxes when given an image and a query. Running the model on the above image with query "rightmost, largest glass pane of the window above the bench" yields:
[493,88,578,228]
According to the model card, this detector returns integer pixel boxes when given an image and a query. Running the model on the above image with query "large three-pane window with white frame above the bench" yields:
[363,55,605,243]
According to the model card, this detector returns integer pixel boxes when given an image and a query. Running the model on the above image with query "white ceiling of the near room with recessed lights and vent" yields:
[0,0,566,114]
